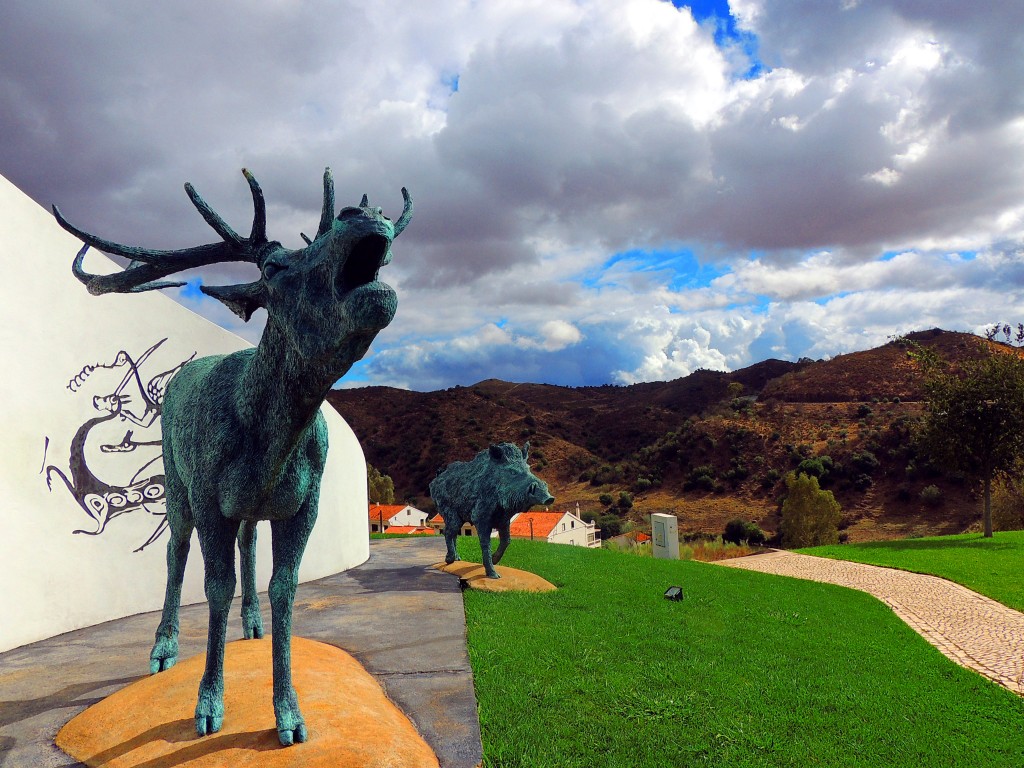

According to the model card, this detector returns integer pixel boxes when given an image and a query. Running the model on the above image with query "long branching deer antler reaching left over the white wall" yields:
[53,168,276,296]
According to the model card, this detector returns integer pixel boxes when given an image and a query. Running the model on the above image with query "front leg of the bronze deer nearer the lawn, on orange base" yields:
[270,493,319,746]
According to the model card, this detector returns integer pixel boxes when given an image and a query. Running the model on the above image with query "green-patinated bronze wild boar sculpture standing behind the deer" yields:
[430,442,555,579]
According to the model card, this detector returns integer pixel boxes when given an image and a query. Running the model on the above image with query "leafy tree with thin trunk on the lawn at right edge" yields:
[910,346,1024,537]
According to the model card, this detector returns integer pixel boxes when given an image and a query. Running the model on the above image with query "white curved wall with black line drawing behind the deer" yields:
[0,171,369,651]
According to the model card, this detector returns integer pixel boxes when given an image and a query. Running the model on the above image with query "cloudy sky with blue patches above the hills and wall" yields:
[0,0,1024,390]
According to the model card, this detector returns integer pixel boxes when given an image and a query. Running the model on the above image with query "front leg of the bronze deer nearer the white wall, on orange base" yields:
[196,518,239,736]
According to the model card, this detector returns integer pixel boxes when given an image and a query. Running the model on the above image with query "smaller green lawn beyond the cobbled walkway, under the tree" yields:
[797,530,1024,610]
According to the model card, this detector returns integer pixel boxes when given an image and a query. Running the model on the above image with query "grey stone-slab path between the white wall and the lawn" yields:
[0,537,482,768]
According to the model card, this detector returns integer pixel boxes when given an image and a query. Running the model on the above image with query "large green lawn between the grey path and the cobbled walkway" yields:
[459,537,1024,768]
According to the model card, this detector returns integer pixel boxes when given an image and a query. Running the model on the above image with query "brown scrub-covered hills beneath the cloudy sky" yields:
[328,329,1017,541]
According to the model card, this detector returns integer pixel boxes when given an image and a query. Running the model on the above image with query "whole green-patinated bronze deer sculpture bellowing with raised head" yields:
[53,168,413,745]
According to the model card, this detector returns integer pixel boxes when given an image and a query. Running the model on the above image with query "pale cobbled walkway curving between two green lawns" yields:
[719,551,1024,695]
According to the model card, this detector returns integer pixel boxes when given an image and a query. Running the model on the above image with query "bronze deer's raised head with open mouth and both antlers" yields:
[53,168,413,375]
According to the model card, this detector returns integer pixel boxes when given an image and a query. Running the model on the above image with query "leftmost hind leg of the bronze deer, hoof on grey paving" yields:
[150,461,194,675]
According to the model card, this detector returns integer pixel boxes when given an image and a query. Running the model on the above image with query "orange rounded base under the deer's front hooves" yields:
[56,637,438,768]
